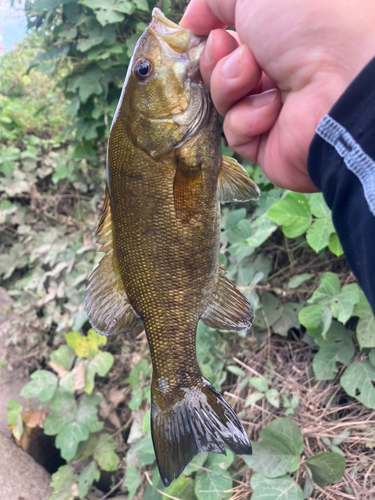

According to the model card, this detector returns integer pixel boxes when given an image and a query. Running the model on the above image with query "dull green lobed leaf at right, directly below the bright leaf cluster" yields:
[313,321,355,380]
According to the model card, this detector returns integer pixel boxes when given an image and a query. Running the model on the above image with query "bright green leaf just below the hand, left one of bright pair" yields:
[267,193,311,238]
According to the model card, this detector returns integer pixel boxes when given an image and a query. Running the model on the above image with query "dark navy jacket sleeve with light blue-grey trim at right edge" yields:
[308,58,375,312]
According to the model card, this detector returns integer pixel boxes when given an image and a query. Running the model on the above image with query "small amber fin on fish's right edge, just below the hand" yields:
[218,156,260,203]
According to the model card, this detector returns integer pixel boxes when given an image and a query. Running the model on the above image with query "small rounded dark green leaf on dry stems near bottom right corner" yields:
[305,451,345,488]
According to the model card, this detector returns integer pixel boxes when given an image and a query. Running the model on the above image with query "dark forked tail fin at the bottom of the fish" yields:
[151,379,252,486]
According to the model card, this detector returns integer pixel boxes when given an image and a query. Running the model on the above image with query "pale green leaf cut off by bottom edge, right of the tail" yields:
[250,474,303,500]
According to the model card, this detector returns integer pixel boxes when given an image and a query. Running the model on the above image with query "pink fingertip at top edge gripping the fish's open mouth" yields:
[180,0,236,35]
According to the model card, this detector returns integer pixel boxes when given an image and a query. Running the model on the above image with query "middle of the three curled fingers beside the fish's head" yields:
[210,45,262,116]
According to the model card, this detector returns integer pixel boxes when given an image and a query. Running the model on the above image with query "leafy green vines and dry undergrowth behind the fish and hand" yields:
[0,0,375,500]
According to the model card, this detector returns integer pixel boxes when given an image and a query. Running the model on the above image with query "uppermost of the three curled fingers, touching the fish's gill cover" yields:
[200,29,238,88]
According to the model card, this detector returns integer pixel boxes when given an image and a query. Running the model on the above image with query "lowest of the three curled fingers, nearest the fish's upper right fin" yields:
[224,89,281,161]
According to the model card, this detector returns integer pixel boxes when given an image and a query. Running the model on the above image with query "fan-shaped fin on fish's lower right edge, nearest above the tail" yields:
[201,271,254,331]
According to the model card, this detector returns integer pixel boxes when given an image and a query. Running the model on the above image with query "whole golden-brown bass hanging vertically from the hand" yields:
[86,8,260,486]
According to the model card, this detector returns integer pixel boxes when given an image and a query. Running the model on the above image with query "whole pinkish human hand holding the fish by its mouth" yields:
[181,0,375,192]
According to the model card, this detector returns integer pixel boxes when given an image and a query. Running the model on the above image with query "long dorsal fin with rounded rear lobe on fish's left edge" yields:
[86,188,139,335]
